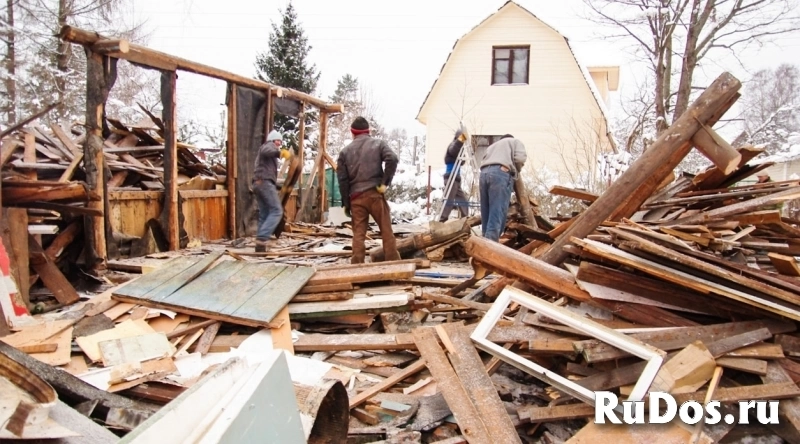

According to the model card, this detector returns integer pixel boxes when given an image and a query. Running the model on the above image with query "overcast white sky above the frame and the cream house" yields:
[128,0,800,141]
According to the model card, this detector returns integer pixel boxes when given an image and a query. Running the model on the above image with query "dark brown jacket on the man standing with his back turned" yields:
[336,134,398,208]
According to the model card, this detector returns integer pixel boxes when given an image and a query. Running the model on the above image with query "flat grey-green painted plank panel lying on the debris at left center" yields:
[113,255,314,328]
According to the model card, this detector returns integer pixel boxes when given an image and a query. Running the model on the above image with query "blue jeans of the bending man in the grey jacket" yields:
[480,165,514,242]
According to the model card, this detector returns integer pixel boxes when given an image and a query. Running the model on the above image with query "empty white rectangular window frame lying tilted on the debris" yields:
[470,287,666,406]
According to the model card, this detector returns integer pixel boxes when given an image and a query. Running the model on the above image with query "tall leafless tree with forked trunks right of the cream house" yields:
[584,0,799,133]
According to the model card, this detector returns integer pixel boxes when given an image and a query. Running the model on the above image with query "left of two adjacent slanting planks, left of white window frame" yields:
[413,328,494,444]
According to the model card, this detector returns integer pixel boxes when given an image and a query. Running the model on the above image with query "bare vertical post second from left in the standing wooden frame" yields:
[161,71,181,250]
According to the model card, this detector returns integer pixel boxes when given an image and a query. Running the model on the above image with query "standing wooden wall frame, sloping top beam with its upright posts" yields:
[59,26,344,269]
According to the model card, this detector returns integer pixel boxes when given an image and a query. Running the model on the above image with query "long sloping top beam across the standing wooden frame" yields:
[59,26,344,112]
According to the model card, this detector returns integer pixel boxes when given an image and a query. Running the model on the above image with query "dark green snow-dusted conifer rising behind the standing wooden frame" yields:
[255,2,320,146]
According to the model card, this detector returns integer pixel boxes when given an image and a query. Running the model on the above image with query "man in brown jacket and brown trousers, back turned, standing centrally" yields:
[336,116,400,264]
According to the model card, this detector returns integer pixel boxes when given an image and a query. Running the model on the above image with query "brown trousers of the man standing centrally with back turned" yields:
[350,190,400,264]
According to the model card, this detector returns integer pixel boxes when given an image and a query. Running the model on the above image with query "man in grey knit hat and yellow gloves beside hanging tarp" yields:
[253,130,291,253]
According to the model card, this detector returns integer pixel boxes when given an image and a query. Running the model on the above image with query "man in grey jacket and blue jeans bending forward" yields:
[480,134,528,242]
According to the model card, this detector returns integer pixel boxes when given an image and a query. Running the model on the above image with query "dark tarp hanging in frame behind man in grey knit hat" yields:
[234,86,267,237]
